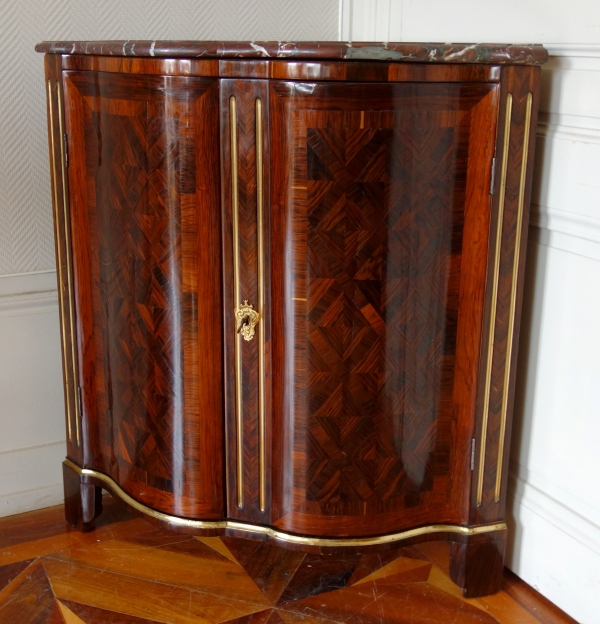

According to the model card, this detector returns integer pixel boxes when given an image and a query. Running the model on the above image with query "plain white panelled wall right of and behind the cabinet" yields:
[340,0,600,624]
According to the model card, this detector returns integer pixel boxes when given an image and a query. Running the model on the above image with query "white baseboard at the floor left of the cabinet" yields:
[0,440,65,517]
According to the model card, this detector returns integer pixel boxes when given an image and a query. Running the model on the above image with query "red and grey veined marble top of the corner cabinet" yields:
[35,39,548,65]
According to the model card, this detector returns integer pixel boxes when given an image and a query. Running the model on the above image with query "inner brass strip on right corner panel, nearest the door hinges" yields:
[477,93,513,507]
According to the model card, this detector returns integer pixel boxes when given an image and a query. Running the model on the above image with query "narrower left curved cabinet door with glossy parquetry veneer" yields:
[63,71,224,518]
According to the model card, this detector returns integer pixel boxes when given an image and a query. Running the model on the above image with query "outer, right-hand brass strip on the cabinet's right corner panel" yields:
[494,93,533,503]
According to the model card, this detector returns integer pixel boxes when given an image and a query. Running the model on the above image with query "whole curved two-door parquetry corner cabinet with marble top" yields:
[37,41,547,596]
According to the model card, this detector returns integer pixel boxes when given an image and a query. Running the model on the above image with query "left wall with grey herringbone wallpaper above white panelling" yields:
[0,0,339,516]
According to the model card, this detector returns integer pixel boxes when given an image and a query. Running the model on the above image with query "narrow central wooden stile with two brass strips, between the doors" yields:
[220,80,270,524]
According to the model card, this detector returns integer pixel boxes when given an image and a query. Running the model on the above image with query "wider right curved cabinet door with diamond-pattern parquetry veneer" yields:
[269,82,498,536]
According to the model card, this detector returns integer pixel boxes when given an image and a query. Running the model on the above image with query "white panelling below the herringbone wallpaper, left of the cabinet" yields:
[0,271,65,516]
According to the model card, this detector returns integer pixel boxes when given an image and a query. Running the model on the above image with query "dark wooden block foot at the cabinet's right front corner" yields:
[450,531,506,598]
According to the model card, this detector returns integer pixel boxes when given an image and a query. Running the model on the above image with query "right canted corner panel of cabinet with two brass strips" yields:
[471,67,540,523]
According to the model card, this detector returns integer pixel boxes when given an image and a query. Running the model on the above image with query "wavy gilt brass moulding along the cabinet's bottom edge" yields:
[64,459,507,547]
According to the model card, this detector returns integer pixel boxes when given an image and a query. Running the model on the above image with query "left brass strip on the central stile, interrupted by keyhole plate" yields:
[229,95,244,508]
